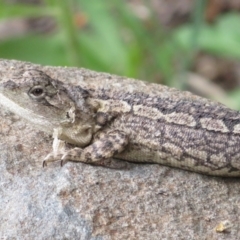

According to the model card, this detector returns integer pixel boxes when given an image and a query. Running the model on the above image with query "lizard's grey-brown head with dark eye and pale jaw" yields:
[0,69,97,146]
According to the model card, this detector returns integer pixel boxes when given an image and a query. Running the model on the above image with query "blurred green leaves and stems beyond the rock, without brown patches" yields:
[0,0,240,103]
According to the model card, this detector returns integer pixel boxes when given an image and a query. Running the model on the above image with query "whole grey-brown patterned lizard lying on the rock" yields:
[0,68,240,177]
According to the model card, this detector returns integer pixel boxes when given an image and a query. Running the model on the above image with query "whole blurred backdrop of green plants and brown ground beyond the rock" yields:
[0,0,240,109]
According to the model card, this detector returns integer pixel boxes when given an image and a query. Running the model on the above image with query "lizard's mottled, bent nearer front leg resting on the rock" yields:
[43,130,128,169]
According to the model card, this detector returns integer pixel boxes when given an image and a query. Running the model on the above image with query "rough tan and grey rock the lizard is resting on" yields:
[0,60,240,240]
